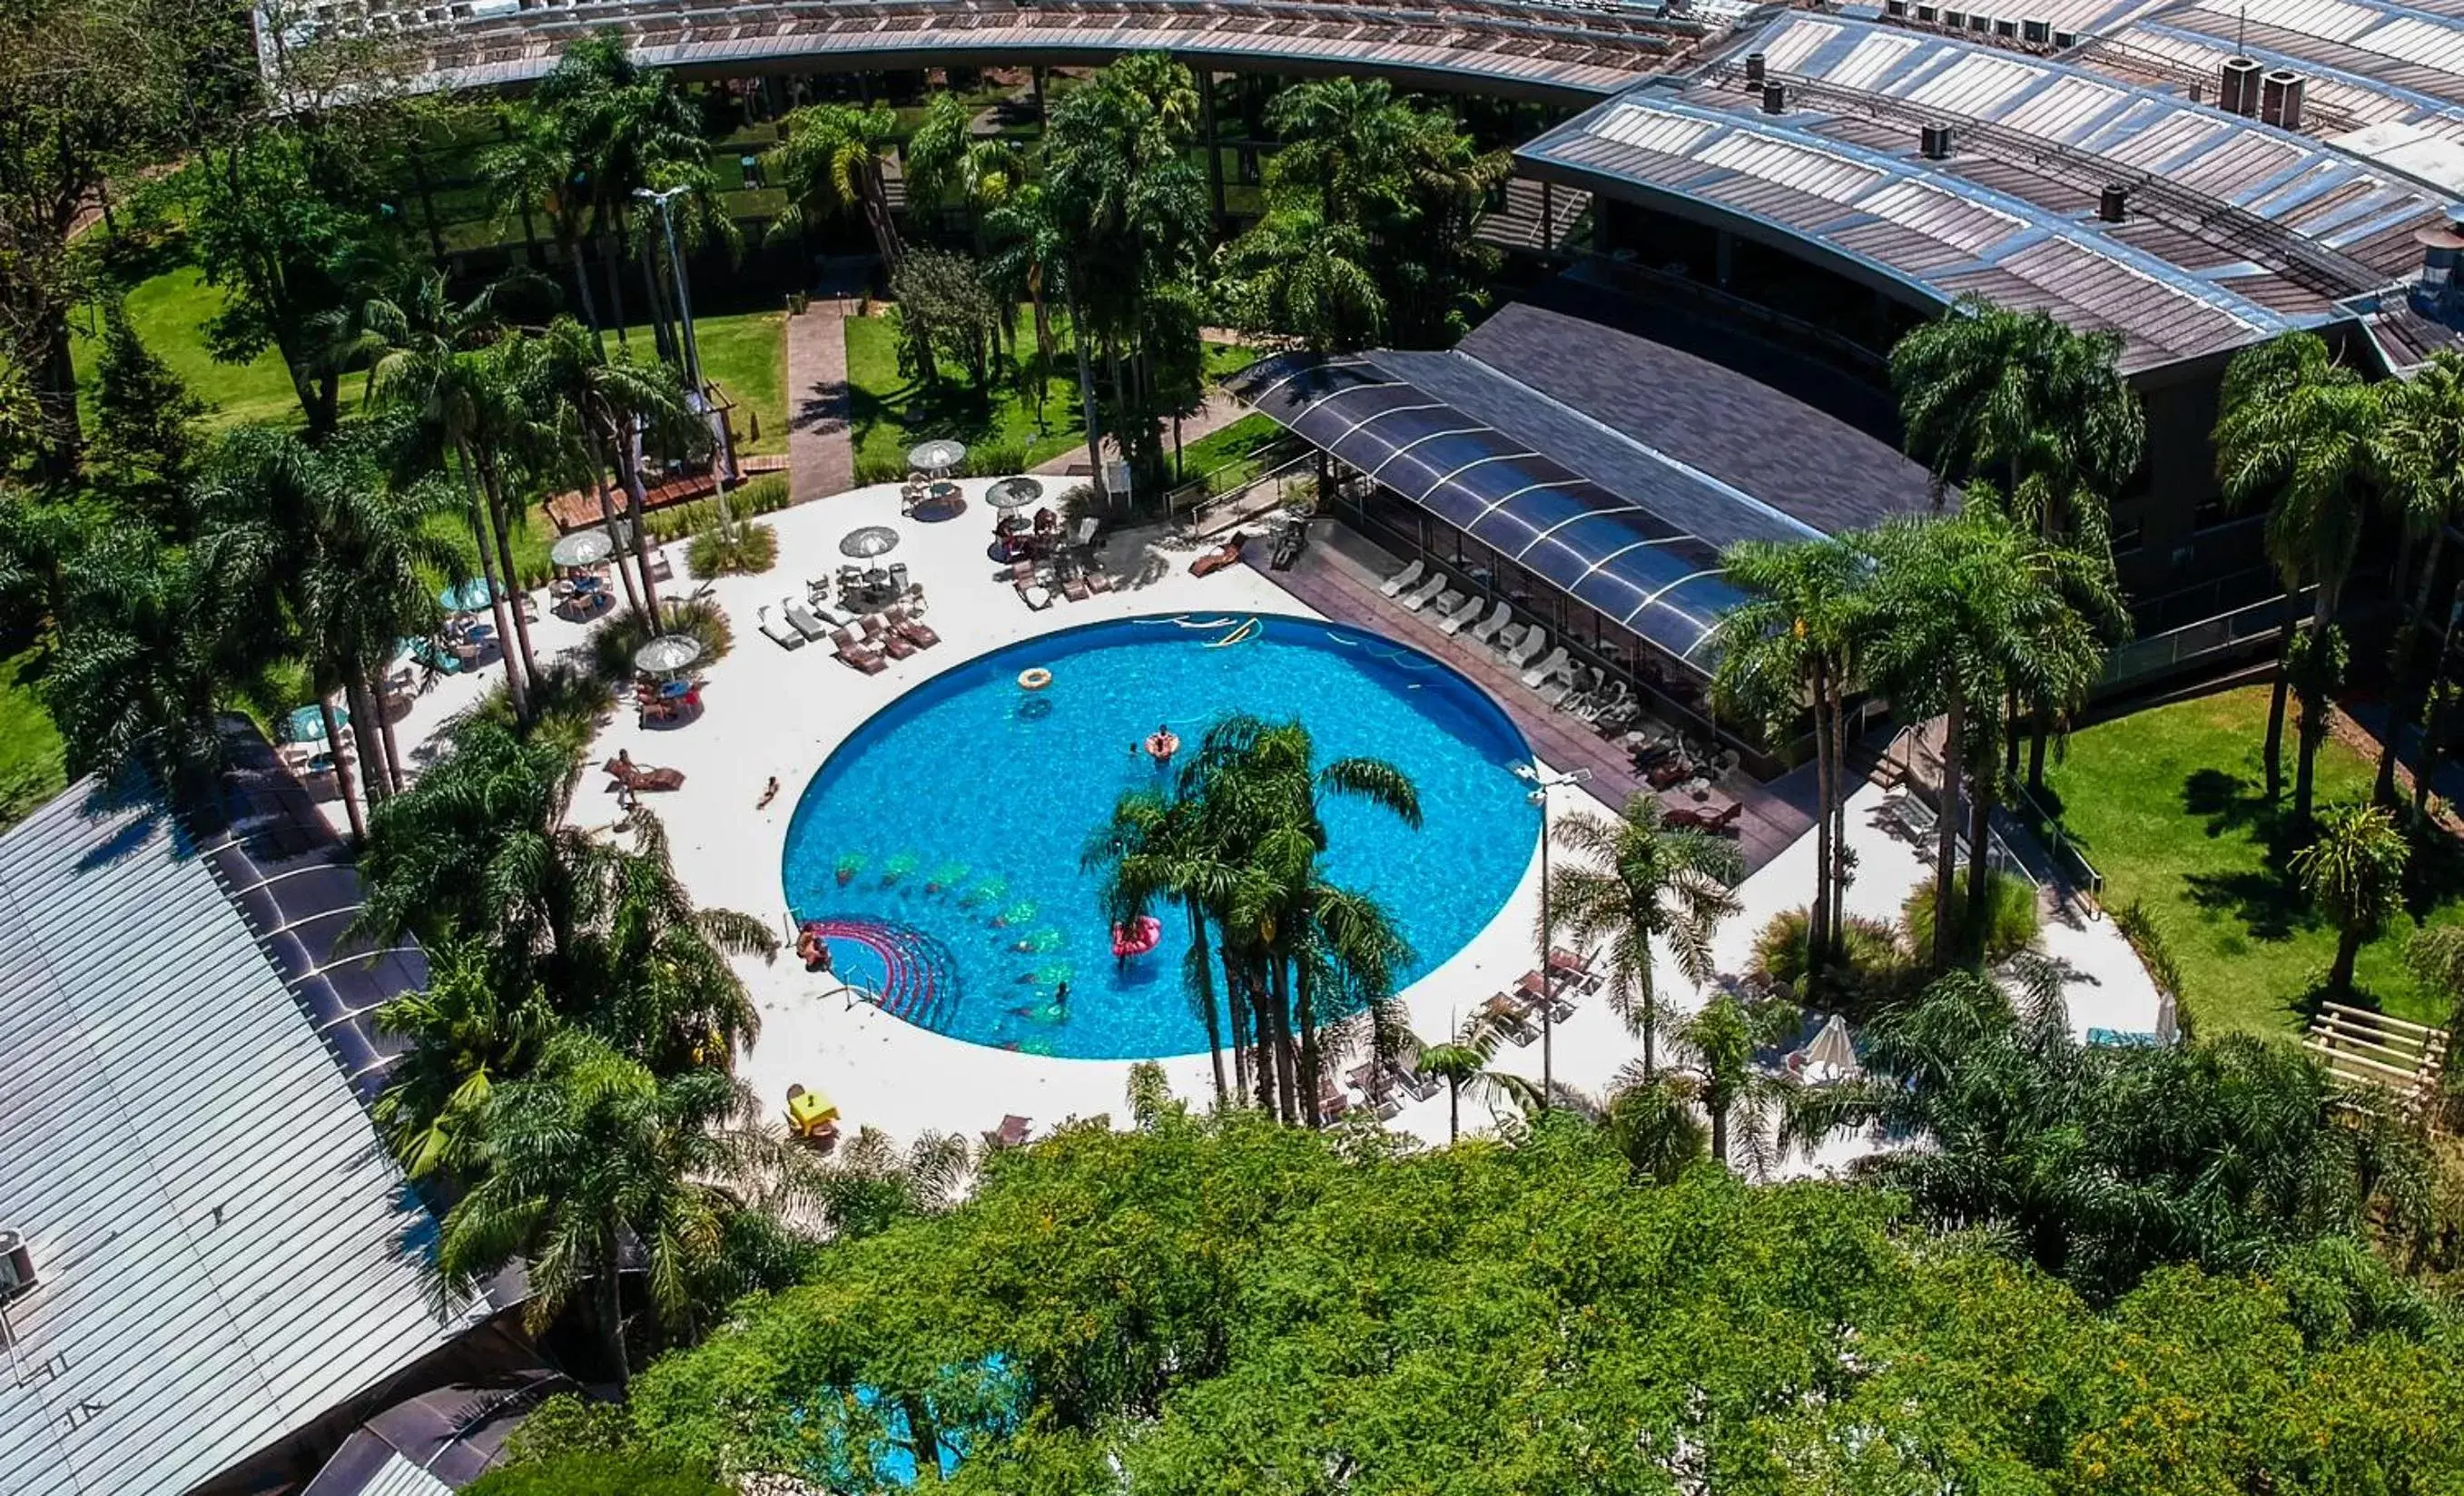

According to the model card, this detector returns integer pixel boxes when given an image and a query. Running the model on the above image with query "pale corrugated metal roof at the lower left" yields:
[0,786,485,1496]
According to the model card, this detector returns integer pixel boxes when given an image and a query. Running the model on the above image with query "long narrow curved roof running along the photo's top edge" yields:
[310,0,1725,101]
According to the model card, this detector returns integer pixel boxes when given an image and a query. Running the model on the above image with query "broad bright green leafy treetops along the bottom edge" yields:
[606,1109,2464,1496]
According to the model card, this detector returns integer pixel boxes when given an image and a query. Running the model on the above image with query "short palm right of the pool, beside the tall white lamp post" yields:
[1547,793,1745,1079]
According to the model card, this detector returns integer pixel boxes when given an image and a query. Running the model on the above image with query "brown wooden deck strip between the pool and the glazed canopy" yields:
[1247,523,1814,872]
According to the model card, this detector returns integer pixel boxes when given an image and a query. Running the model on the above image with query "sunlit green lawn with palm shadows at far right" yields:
[2045,687,2464,1033]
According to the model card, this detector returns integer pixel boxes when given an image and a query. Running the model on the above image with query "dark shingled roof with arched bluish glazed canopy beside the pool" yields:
[1235,306,1927,668]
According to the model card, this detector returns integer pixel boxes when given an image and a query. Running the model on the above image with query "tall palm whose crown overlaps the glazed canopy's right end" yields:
[1712,540,1870,981]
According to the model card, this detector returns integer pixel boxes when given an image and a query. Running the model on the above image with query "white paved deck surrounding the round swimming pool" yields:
[323,480,2156,1166]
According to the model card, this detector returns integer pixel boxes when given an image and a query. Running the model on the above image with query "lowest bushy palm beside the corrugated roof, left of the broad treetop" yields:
[436,1030,786,1383]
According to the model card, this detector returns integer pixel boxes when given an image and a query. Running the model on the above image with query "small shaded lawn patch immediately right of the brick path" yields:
[848,308,1087,480]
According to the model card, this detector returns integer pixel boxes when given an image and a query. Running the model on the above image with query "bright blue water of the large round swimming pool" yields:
[784,614,1540,1059]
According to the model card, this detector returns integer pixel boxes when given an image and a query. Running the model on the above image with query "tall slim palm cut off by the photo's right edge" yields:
[2370,348,2464,806]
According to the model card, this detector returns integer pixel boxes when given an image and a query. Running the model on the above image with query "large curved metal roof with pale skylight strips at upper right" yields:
[1518,15,2454,372]
